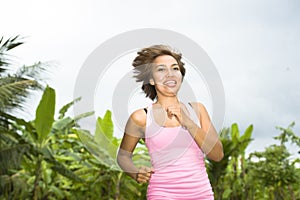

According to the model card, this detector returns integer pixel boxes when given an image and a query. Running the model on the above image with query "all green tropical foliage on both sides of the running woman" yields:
[0,37,300,200]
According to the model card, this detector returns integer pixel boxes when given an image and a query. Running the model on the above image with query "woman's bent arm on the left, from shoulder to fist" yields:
[117,109,153,183]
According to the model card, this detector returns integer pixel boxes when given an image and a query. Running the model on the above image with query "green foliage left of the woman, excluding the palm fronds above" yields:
[0,87,147,199]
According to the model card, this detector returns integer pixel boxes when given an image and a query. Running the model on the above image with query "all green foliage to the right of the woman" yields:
[207,123,300,200]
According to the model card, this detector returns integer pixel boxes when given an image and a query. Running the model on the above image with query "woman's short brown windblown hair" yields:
[132,45,185,100]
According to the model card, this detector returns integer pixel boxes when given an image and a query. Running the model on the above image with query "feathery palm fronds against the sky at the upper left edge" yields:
[0,36,45,112]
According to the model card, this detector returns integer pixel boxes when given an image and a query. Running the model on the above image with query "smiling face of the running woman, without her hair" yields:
[150,55,182,96]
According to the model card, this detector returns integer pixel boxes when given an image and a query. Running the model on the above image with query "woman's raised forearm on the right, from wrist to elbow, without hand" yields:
[186,121,223,161]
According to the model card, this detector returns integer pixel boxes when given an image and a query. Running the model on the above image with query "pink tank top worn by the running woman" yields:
[145,104,214,200]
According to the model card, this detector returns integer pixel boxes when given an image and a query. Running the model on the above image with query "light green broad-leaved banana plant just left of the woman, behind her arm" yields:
[73,111,149,199]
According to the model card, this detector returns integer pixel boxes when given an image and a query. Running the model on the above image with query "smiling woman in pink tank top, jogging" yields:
[117,45,223,200]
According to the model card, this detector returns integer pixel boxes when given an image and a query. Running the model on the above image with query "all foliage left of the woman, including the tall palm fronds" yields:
[0,36,146,199]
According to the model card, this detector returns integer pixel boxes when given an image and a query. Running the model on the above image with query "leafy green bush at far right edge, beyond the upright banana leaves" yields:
[249,122,300,200]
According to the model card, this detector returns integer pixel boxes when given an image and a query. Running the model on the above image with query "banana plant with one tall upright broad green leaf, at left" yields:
[0,86,87,199]
